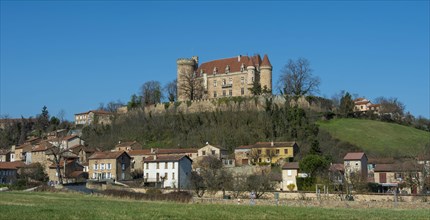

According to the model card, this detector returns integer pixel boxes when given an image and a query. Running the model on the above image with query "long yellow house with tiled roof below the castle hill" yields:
[240,142,299,165]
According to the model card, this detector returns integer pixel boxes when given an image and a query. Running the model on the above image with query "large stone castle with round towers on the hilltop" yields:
[176,54,272,101]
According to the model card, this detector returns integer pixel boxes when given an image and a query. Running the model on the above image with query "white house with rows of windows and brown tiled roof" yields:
[143,155,193,189]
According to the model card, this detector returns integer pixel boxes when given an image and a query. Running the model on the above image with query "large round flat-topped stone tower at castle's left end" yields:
[176,56,199,101]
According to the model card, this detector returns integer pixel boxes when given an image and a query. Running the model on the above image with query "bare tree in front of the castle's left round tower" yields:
[178,69,204,100]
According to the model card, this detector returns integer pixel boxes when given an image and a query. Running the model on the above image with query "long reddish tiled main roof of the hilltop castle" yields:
[197,55,268,75]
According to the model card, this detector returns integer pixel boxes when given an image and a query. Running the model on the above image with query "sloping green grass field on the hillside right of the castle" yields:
[318,119,430,156]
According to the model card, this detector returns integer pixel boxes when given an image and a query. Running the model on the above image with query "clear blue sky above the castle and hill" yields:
[0,1,430,120]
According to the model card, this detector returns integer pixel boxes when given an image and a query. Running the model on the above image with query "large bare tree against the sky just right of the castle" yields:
[279,58,320,97]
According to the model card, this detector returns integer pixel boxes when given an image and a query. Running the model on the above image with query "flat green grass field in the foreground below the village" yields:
[0,192,430,220]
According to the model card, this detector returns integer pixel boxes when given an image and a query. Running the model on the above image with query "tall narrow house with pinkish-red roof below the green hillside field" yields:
[343,152,368,182]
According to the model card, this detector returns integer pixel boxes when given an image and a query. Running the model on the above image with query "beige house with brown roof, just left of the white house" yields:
[88,151,131,181]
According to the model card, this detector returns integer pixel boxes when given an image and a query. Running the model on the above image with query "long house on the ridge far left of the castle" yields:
[75,110,113,125]
